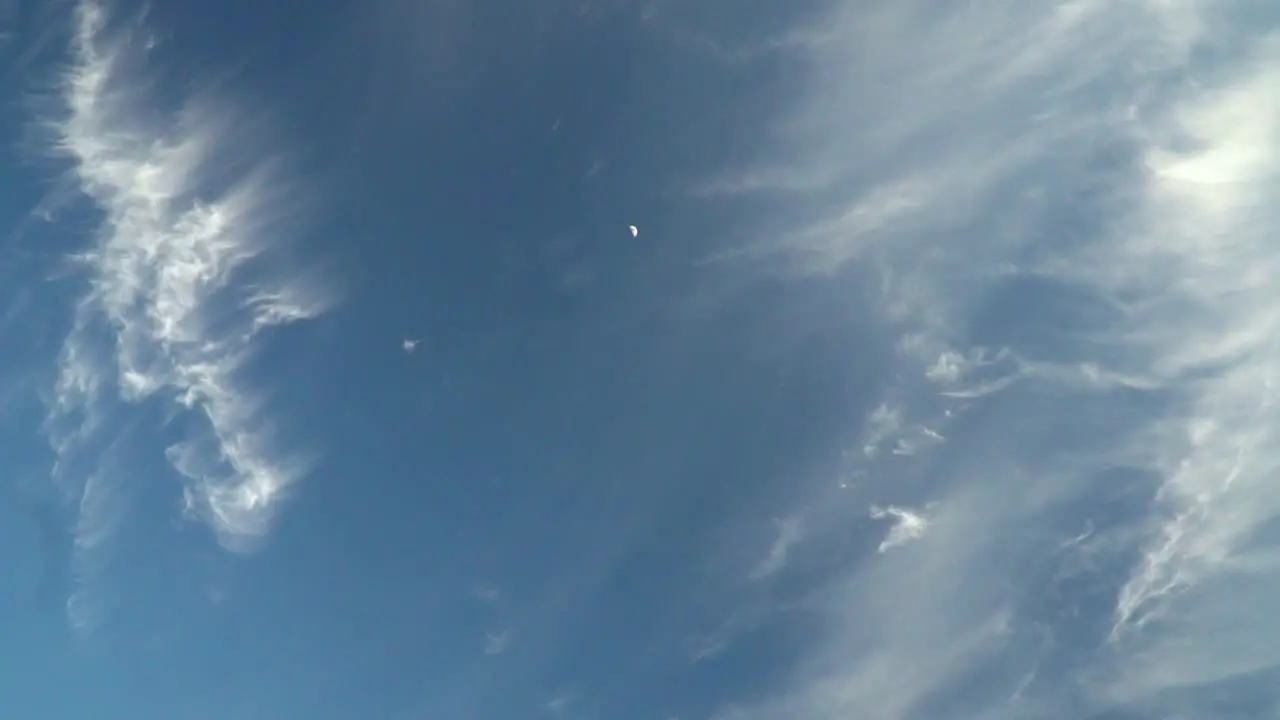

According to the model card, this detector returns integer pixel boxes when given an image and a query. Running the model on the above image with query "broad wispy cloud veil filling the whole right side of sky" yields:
[699,0,1280,720]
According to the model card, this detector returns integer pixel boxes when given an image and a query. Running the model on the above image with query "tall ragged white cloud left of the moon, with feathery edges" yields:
[46,0,335,576]
